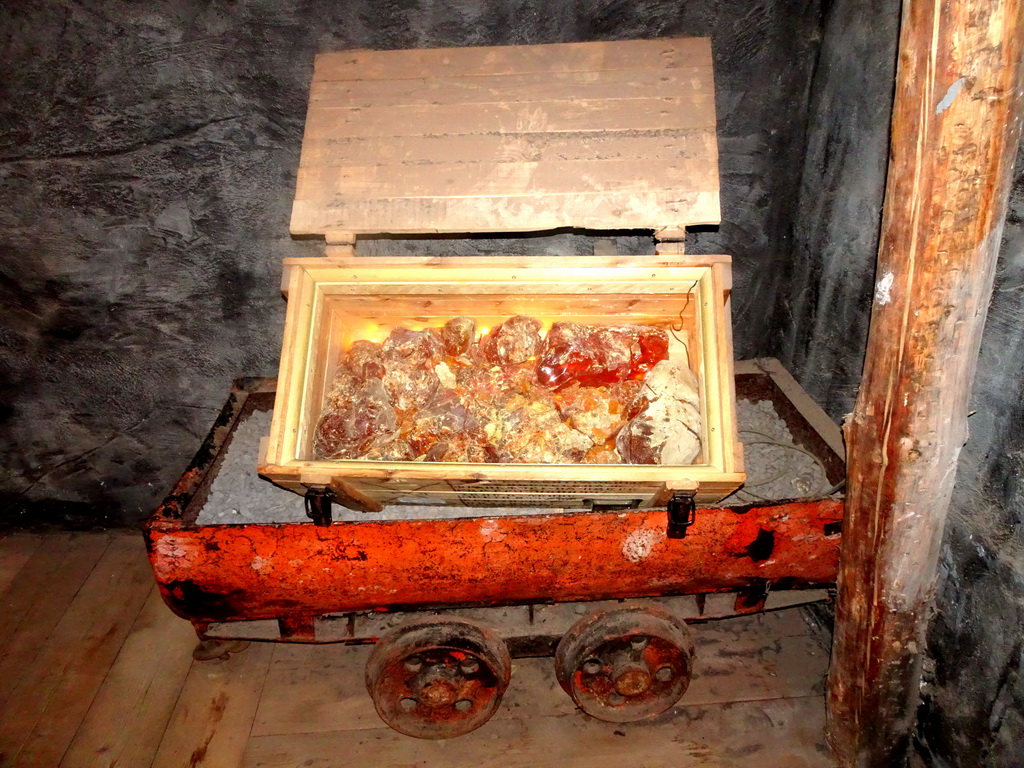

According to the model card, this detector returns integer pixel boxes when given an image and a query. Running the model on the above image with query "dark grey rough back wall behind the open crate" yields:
[0,0,820,525]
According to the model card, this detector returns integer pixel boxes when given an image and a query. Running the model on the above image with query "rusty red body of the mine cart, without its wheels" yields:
[145,364,843,642]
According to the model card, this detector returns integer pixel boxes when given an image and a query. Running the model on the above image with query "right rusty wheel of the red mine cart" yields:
[555,607,693,723]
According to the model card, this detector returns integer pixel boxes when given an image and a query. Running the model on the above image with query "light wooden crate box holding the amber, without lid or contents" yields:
[259,256,744,508]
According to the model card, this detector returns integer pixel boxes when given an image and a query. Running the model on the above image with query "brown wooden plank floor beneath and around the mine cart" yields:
[0,532,831,768]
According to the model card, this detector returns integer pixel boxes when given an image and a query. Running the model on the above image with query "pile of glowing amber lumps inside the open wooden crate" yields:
[313,315,700,464]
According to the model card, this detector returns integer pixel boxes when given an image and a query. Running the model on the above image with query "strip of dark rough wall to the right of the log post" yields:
[919,144,1024,768]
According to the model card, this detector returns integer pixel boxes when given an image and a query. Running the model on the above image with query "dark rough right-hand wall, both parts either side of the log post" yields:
[776,0,1024,768]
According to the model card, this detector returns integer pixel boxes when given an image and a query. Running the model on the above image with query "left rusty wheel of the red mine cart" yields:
[367,616,512,738]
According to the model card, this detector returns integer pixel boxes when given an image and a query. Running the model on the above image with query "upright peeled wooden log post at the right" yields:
[828,0,1024,768]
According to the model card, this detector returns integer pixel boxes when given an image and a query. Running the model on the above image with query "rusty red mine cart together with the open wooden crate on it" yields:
[146,39,843,738]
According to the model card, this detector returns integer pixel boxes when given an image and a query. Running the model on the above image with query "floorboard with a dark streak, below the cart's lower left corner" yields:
[153,643,272,768]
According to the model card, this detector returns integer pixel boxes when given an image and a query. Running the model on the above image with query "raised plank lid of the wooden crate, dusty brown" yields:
[292,38,721,234]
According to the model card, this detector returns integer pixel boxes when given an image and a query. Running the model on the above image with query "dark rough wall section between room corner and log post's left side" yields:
[775,0,900,419]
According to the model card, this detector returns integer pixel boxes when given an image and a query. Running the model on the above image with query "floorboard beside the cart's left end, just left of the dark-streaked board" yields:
[60,587,196,768]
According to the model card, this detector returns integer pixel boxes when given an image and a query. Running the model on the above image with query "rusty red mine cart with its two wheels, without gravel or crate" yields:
[144,360,844,738]
